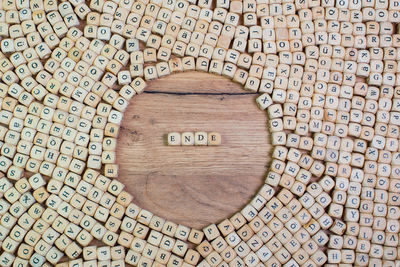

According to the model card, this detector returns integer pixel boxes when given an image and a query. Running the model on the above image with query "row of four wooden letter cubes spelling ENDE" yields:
[167,132,221,146]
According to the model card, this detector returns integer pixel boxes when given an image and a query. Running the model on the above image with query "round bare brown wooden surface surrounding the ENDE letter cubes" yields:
[117,72,272,228]
